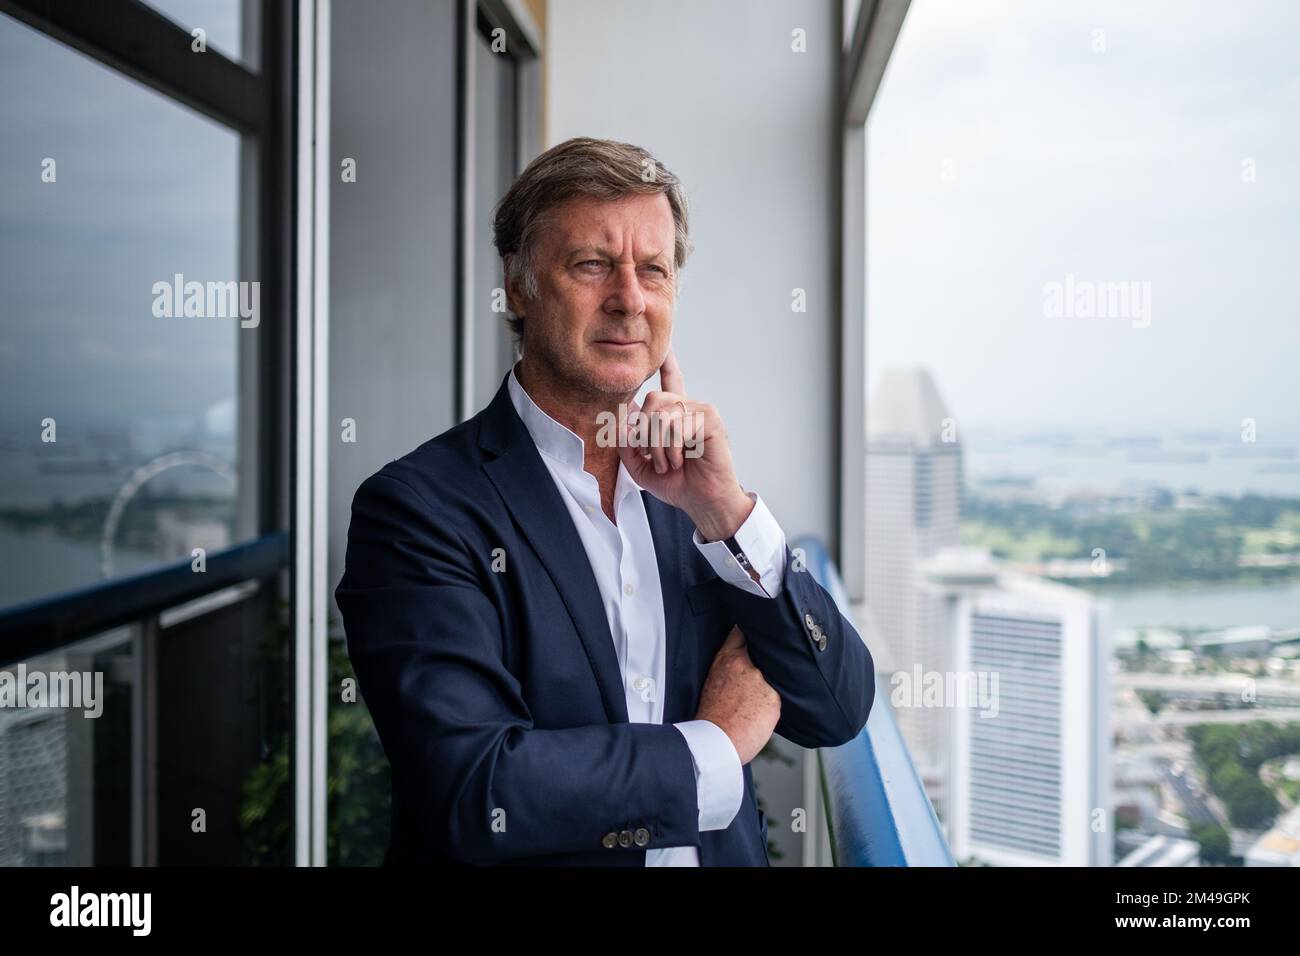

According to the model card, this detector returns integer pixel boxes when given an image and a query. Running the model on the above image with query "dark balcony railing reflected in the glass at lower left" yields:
[0,531,290,866]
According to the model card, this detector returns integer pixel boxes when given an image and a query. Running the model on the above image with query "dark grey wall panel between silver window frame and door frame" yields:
[328,0,458,633]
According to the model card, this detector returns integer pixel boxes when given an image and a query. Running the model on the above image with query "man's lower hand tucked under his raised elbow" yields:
[696,627,781,766]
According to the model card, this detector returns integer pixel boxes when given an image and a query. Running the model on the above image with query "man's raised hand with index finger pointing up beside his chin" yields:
[619,347,754,541]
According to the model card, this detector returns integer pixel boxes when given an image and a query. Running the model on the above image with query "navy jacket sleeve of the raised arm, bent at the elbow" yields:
[722,546,876,748]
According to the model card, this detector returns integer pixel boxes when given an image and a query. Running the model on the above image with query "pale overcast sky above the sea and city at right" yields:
[867,0,1300,442]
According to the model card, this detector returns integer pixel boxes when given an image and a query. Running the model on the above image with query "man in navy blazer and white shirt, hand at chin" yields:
[335,138,875,866]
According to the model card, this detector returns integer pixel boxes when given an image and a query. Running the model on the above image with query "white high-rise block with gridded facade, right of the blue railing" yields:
[924,549,1113,866]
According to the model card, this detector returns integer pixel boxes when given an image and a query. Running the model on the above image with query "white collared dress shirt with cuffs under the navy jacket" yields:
[508,368,785,866]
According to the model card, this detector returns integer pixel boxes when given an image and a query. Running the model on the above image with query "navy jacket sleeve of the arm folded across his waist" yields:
[335,471,699,864]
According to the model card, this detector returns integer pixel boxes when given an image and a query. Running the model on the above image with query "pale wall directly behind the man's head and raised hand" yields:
[546,0,839,544]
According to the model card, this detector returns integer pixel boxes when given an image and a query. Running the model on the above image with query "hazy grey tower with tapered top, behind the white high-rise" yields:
[866,368,962,801]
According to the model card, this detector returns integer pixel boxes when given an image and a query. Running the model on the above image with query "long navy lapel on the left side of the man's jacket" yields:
[478,372,628,723]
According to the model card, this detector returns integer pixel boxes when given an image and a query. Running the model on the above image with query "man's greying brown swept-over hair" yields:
[493,137,692,341]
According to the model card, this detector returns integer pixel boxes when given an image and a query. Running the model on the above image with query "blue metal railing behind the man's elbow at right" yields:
[792,536,957,866]
